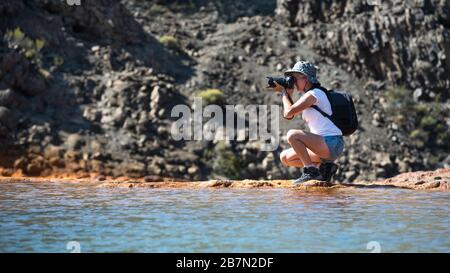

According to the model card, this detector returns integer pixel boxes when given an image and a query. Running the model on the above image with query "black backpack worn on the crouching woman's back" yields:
[311,86,358,136]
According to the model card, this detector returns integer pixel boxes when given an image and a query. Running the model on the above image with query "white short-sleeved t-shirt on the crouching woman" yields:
[302,88,342,136]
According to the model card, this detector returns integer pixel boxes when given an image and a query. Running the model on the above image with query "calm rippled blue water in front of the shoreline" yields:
[0,183,450,252]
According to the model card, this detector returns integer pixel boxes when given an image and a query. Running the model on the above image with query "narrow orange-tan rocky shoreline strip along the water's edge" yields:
[0,168,450,191]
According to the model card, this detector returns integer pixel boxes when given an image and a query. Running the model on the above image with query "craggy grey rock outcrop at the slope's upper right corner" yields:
[277,0,450,101]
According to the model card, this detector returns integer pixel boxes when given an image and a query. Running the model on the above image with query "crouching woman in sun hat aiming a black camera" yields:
[268,61,348,184]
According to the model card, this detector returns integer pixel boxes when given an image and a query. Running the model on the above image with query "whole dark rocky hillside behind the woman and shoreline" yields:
[0,0,450,181]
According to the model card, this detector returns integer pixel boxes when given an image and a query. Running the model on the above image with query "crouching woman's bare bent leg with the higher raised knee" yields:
[287,130,330,166]
